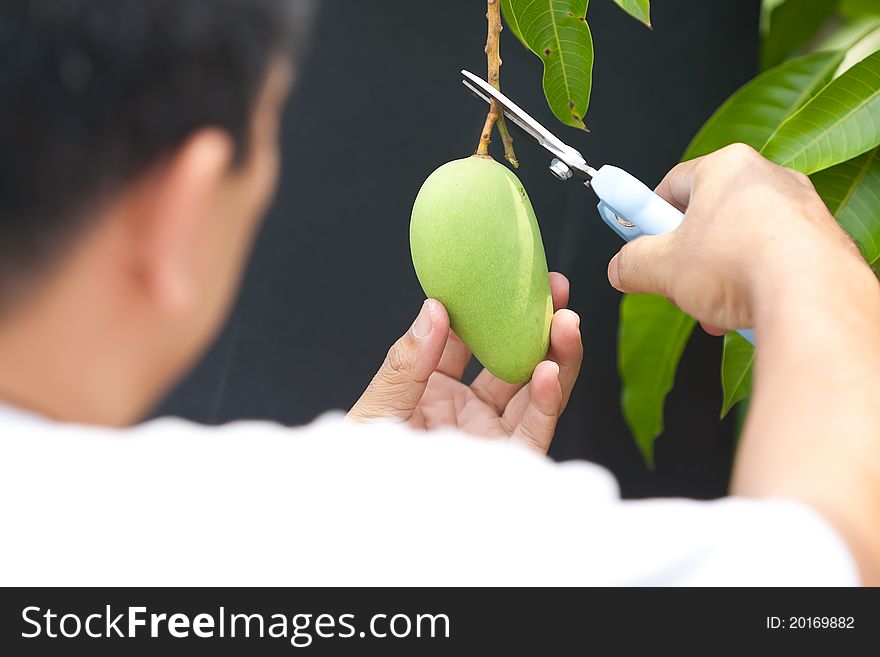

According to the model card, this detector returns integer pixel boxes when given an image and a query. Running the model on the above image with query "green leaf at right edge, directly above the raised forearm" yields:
[813,148,880,266]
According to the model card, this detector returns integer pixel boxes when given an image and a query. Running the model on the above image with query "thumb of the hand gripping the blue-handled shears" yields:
[608,233,672,296]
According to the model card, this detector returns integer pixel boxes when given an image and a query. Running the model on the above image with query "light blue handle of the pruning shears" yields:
[590,164,755,344]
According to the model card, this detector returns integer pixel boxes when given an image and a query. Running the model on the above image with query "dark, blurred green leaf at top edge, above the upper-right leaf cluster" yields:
[761,0,839,69]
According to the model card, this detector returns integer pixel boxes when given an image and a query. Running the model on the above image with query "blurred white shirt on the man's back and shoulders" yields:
[0,409,858,586]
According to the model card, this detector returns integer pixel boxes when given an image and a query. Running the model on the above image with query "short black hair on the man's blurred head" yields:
[0,0,295,300]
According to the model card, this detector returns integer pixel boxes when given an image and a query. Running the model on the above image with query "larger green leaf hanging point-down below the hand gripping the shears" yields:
[618,294,696,467]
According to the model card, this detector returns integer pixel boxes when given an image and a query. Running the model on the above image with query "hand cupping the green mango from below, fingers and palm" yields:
[348,272,583,453]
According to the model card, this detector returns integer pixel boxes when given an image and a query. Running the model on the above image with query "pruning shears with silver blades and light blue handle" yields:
[461,71,755,344]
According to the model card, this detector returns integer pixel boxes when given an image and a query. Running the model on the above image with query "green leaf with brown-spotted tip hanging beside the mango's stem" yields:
[501,0,593,130]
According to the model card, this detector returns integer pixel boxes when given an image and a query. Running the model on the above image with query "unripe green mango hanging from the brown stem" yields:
[410,156,553,383]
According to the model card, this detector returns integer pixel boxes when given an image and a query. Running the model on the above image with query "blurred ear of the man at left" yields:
[130,129,234,312]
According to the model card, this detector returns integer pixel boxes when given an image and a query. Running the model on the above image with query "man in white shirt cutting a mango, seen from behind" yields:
[0,0,880,585]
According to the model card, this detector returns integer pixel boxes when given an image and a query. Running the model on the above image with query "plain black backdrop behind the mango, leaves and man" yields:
[159,0,758,498]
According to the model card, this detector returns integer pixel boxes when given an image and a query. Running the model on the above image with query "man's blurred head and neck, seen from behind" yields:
[0,0,302,422]
